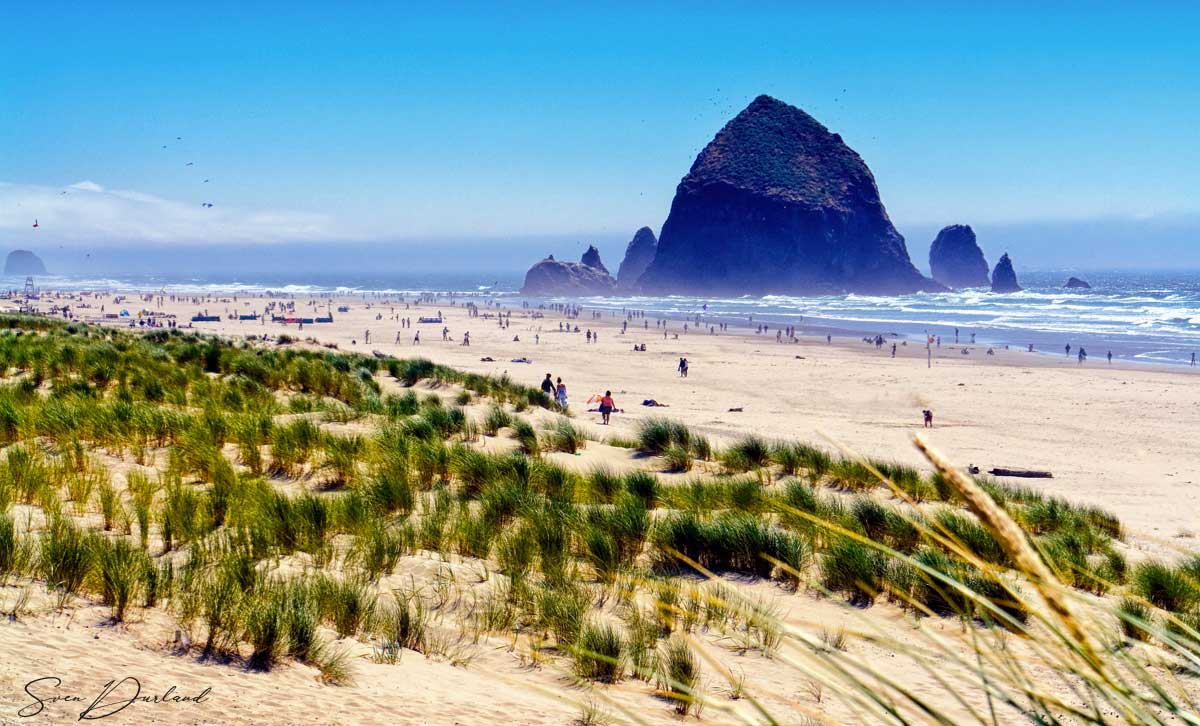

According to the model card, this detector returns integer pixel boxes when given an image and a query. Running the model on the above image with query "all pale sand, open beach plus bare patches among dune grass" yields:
[0,285,1200,724]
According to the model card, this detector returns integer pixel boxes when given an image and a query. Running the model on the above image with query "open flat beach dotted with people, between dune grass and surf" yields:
[18,285,1200,552]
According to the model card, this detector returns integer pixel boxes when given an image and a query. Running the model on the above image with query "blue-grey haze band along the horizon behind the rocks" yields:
[14,212,1200,276]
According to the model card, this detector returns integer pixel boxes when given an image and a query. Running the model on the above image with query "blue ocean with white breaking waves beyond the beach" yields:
[9,271,1200,365]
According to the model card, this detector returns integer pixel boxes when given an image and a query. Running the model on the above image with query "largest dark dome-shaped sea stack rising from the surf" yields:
[637,96,944,295]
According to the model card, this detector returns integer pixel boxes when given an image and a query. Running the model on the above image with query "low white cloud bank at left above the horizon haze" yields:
[0,180,344,247]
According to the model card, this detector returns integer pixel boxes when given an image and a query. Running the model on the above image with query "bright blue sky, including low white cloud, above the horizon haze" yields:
[0,1,1200,266]
